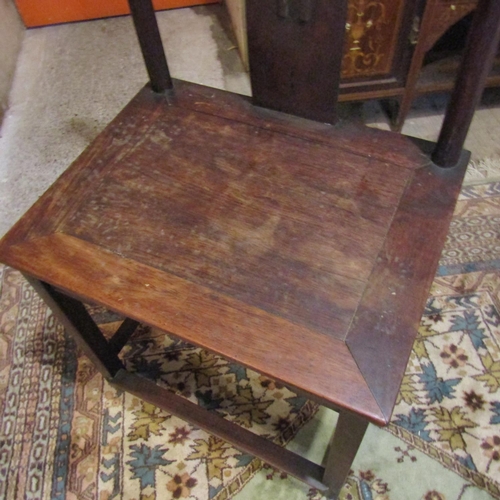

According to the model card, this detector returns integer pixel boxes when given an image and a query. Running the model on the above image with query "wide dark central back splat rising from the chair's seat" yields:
[246,0,347,123]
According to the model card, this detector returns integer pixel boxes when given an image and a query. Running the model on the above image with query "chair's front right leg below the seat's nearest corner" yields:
[323,412,368,499]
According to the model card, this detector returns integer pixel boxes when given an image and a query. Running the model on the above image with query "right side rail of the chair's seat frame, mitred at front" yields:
[347,146,469,419]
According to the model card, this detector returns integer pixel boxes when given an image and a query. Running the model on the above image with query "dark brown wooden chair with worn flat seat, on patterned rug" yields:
[0,0,500,498]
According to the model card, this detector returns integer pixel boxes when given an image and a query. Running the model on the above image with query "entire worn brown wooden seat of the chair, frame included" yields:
[0,83,463,425]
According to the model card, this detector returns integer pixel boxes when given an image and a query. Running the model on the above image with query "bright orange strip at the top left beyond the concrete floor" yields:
[16,0,218,28]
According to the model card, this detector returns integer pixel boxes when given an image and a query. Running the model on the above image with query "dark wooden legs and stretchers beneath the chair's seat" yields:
[25,275,368,499]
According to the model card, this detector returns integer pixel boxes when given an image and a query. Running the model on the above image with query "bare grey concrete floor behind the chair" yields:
[0,6,500,235]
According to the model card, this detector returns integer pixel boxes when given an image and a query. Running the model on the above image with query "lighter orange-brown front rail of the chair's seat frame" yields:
[2,233,382,425]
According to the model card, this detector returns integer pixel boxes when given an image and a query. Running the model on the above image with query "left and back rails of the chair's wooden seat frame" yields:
[0,84,429,254]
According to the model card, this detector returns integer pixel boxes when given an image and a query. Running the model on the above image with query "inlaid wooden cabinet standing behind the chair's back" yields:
[226,0,500,131]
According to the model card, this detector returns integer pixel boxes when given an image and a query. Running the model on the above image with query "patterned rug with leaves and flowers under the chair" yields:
[0,183,500,500]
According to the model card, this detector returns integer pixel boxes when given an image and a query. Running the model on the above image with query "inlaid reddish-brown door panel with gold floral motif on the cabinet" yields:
[342,0,405,79]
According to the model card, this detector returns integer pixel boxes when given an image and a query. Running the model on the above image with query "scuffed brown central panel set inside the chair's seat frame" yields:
[57,102,408,338]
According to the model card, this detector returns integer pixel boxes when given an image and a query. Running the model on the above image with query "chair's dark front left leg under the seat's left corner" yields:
[24,275,124,379]
